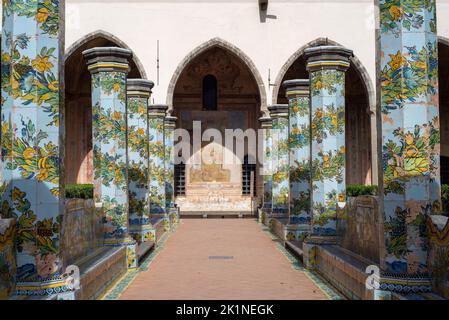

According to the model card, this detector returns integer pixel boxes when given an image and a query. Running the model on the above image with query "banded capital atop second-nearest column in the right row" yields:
[304,46,354,72]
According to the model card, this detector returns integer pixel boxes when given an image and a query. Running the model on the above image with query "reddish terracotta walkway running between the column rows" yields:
[114,219,328,300]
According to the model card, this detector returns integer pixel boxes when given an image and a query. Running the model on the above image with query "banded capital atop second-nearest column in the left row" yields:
[82,47,133,73]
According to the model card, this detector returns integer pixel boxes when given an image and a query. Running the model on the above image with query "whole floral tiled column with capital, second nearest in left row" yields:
[83,47,137,268]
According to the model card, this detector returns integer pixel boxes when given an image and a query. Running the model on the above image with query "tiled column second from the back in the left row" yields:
[148,105,169,225]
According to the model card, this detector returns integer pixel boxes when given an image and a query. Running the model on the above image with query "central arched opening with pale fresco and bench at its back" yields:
[172,43,261,215]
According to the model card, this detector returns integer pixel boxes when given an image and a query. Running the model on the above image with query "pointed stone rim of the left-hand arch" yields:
[64,30,147,79]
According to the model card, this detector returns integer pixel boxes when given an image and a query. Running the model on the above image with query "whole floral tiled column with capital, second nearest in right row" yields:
[305,46,352,242]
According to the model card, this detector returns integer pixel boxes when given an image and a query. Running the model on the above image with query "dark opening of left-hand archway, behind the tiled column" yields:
[65,32,144,183]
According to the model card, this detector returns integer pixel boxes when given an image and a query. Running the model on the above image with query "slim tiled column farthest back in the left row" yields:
[164,116,178,223]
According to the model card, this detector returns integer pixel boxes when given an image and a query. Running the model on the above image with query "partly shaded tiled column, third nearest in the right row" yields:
[283,79,312,240]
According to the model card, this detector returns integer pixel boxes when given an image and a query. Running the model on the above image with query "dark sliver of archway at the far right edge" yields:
[438,38,449,184]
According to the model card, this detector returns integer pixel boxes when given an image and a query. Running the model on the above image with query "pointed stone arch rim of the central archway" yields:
[167,38,268,114]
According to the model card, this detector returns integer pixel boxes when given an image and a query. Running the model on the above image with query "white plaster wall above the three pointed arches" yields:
[66,0,376,103]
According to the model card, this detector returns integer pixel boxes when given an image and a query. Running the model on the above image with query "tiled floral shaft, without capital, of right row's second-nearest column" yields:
[310,69,346,235]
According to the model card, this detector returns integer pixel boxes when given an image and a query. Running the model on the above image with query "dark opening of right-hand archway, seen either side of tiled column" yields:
[274,39,376,184]
